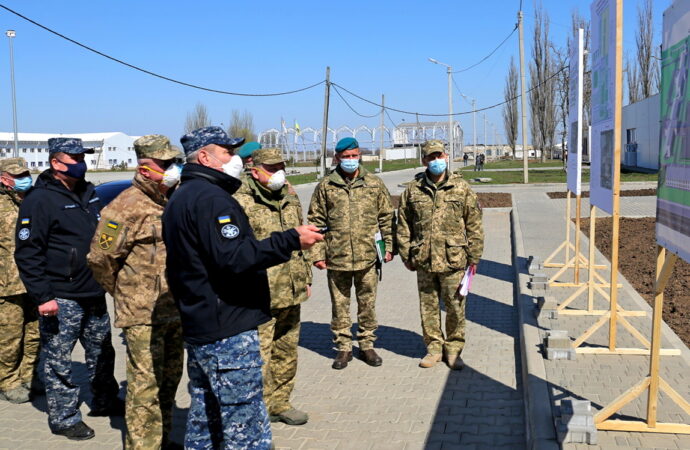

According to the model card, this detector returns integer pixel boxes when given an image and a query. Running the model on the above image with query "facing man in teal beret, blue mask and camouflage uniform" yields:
[309,138,394,369]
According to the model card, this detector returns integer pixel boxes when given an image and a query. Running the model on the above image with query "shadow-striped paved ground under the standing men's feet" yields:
[0,174,525,450]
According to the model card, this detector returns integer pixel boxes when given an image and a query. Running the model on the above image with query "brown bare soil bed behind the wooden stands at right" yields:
[580,217,690,346]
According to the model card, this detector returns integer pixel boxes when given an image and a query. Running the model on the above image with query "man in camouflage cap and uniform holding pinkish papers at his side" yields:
[396,140,484,370]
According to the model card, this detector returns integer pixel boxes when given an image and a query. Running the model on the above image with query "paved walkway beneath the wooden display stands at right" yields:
[514,187,690,449]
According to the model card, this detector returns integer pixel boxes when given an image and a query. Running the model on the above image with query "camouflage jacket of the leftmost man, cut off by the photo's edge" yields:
[0,187,26,297]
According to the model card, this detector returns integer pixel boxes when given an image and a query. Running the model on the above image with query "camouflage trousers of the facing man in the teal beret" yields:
[328,265,378,351]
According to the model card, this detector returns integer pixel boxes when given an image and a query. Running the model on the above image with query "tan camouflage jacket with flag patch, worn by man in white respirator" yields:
[88,174,180,328]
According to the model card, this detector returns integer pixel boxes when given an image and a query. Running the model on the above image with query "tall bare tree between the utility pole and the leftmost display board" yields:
[529,3,557,162]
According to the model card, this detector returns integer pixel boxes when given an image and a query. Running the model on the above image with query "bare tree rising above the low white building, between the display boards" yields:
[631,0,659,103]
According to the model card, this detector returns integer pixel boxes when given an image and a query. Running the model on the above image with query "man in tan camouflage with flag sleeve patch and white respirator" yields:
[88,134,184,449]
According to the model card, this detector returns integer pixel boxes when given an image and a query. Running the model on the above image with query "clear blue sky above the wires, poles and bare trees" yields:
[0,0,670,143]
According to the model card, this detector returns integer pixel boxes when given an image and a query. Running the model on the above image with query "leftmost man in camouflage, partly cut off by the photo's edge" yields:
[0,158,40,403]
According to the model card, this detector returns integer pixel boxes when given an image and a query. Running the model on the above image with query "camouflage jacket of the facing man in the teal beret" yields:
[308,166,395,271]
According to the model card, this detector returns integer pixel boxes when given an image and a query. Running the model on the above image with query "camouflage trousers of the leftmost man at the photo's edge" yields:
[0,295,40,391]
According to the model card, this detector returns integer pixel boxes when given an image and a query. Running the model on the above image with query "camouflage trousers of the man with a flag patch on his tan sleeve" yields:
[123,321,184,449]
